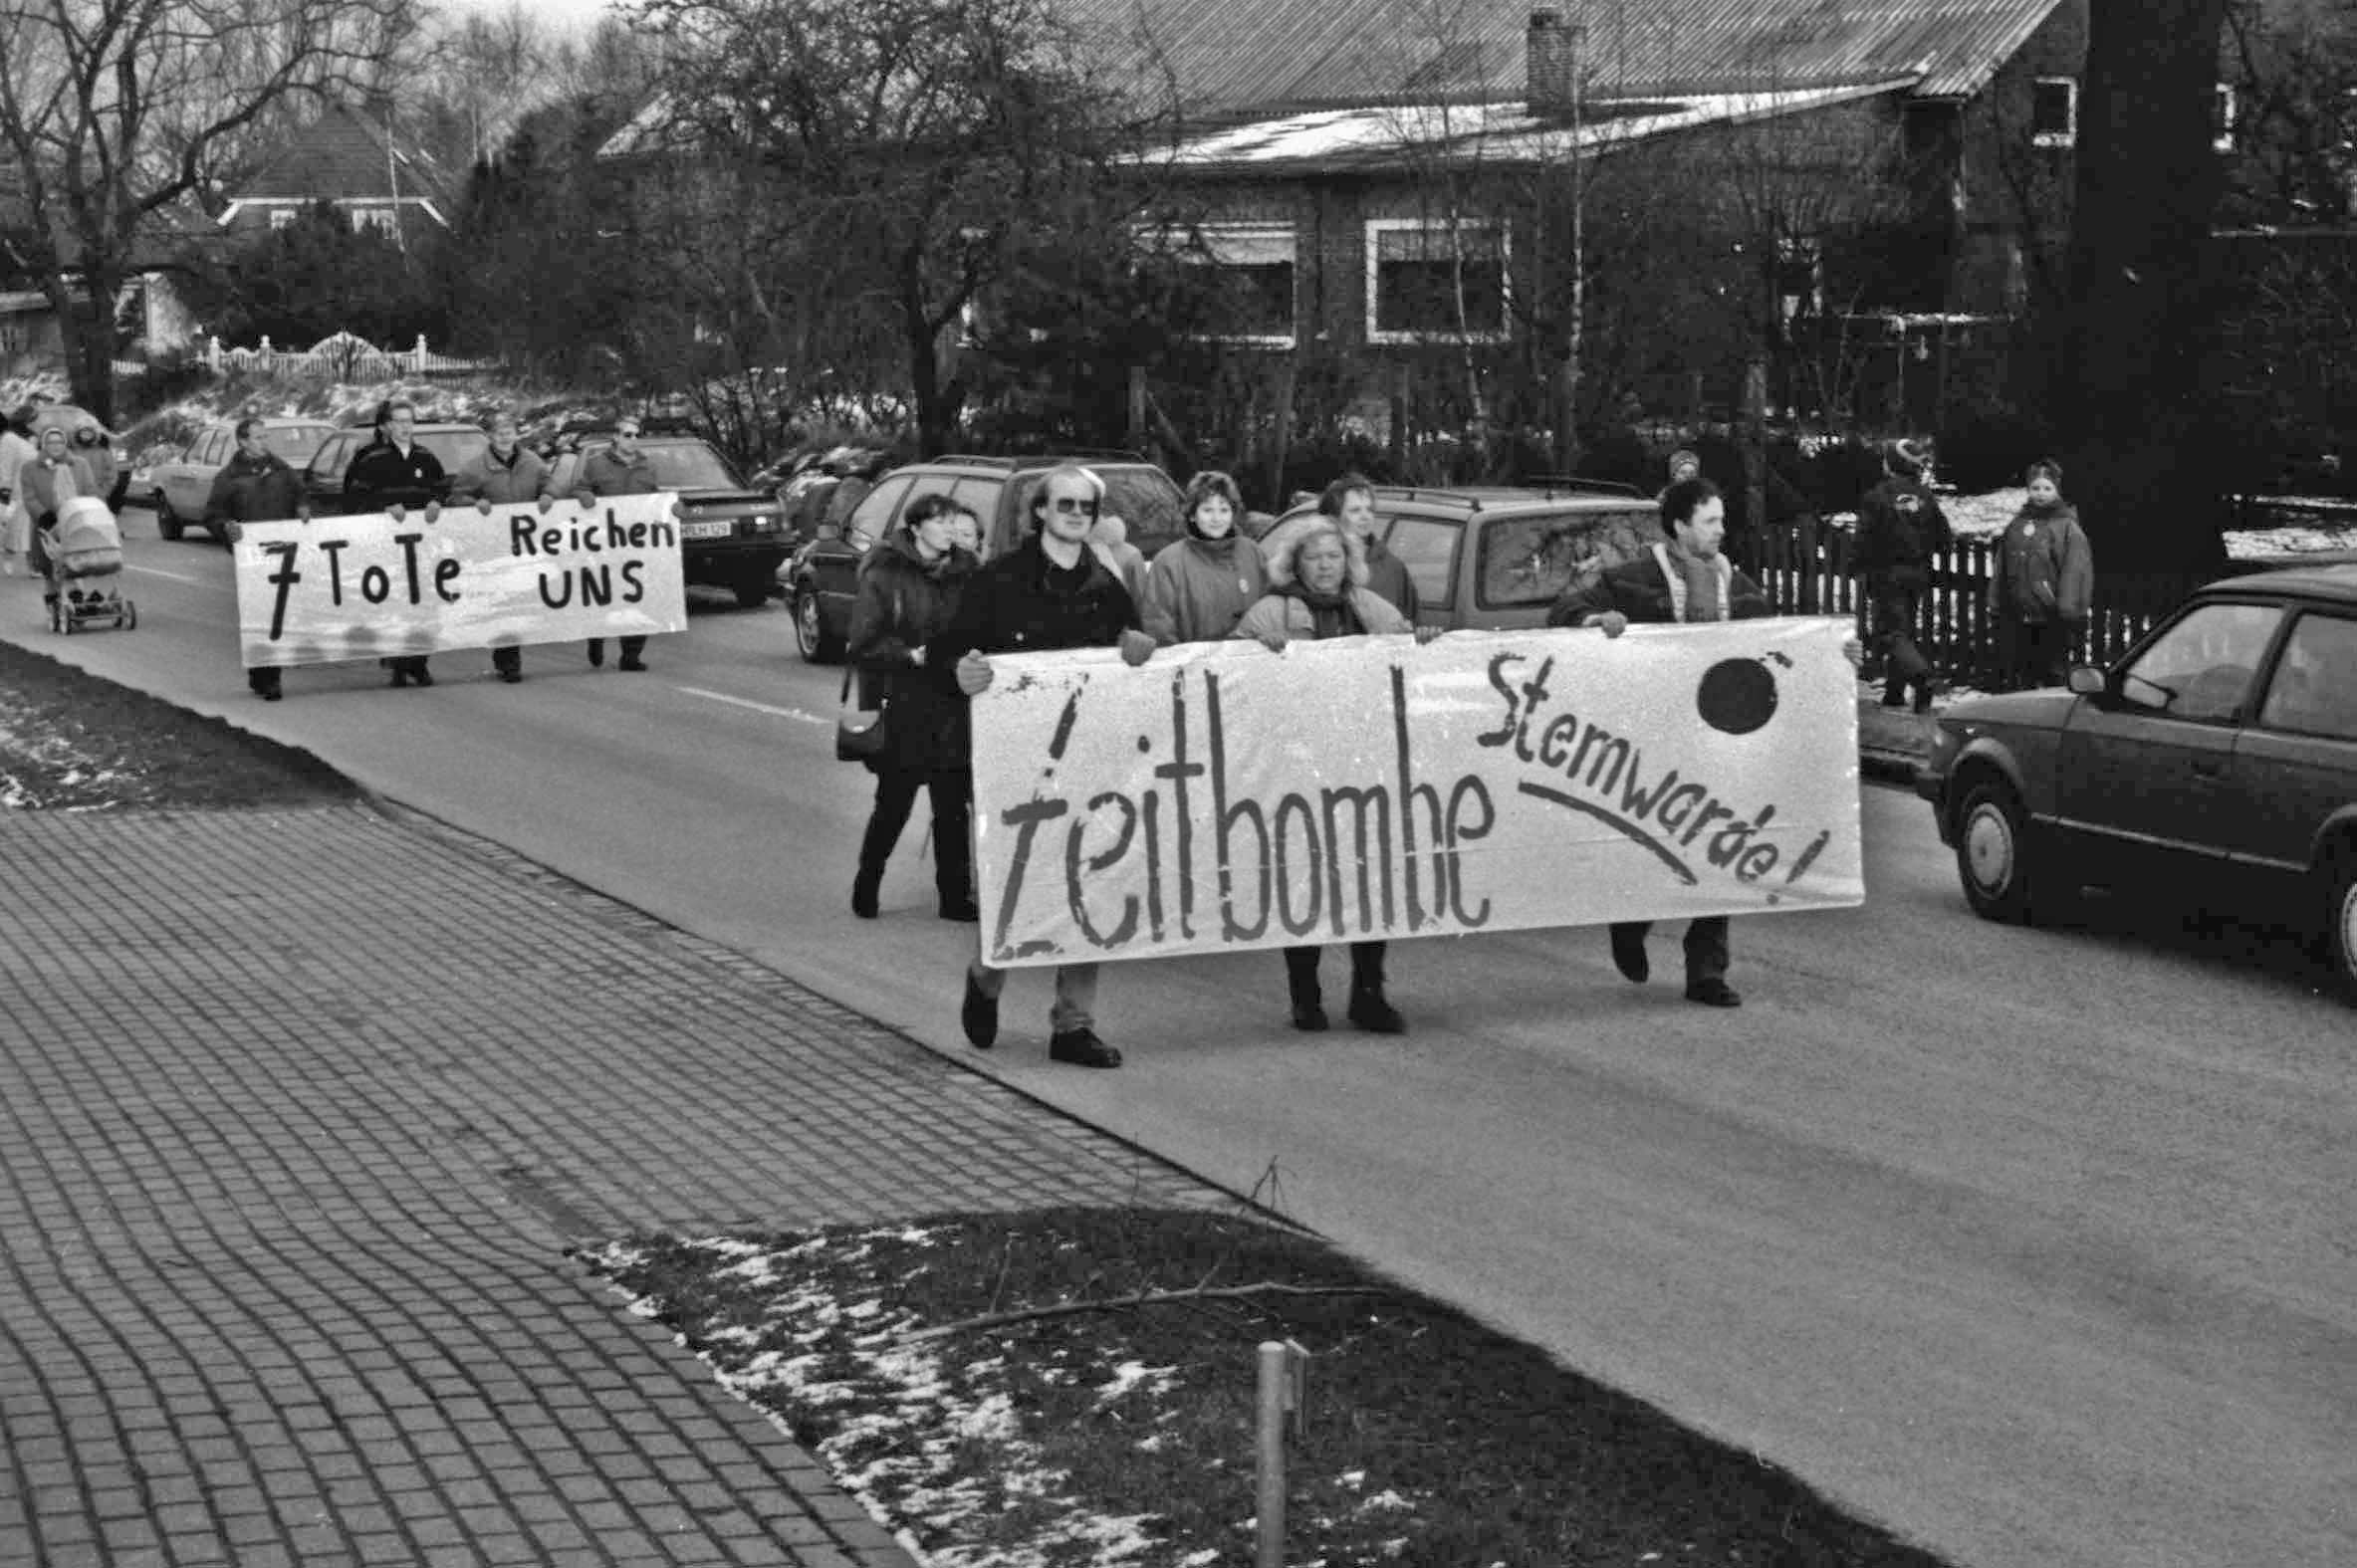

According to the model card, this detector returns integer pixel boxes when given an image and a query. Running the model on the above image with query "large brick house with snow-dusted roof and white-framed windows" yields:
[1070,0,2086,433]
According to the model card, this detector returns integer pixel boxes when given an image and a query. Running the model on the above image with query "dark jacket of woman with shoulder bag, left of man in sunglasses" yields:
[846,529,981,774]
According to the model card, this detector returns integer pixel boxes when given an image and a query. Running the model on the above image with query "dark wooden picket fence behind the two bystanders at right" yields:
[1737,529,2192,691]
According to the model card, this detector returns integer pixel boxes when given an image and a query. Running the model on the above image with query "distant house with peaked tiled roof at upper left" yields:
[217,104,457,236]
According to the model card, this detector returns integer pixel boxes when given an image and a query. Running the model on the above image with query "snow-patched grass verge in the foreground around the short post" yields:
[587,1210,1938,1568]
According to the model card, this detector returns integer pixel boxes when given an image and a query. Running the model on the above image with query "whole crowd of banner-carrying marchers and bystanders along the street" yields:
[0,398,2093,1068]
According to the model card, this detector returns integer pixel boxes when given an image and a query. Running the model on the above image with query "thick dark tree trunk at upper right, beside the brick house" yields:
[2055,0,2228,601]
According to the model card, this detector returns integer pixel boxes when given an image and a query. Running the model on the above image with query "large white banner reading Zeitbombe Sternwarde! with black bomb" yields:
[966,618,1864,965]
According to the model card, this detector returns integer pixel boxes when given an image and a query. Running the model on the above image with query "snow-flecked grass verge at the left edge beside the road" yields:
[0,644,358,811]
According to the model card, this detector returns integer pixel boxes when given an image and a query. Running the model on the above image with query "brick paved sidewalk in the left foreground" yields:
[0,806,1226,1568]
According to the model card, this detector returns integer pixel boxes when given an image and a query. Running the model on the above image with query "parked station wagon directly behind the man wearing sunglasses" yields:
[785,453,1186,665]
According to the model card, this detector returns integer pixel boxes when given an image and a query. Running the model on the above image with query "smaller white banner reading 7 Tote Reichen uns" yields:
[236,493,688,670]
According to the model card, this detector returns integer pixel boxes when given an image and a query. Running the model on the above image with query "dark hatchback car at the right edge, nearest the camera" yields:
[1916,565,2357,998]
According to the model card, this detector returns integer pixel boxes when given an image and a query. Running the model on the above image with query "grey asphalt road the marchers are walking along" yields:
[0,514,2357,1568]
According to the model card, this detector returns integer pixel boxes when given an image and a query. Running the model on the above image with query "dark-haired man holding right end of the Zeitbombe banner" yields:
[1546,479,1864,1007]
